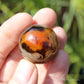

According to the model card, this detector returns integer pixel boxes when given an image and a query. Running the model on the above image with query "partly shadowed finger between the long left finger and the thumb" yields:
[0,46,23,82]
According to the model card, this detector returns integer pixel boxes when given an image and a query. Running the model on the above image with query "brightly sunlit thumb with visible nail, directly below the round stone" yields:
[8,60,38,84]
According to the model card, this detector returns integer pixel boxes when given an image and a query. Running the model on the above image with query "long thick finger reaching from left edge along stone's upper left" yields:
[0,13,33,68]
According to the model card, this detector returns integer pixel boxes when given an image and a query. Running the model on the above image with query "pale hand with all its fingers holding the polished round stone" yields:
[0,8,69,84]
